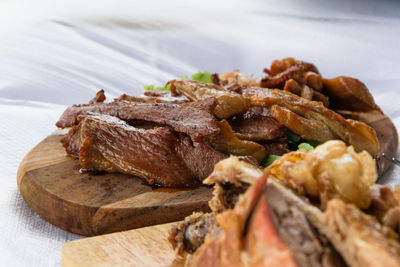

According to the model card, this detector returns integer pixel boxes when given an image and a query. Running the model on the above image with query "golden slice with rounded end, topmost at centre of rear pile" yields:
[170,80,250,119]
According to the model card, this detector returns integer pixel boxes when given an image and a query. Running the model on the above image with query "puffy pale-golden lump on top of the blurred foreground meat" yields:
[265,141,377,208]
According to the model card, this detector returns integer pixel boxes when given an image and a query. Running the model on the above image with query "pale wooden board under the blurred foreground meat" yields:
[61,223,182,267]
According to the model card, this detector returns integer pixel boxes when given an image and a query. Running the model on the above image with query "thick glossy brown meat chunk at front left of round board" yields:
[64,115,226,187]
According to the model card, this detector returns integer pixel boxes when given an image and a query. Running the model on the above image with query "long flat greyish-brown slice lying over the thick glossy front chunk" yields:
[56,98,219,141]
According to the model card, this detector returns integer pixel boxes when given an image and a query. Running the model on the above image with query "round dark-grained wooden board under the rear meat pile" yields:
[17,112,398,236]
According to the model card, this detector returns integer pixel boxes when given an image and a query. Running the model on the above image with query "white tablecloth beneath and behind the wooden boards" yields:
[0,0,400,266]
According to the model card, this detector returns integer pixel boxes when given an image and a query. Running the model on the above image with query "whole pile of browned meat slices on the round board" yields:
[56,58,381,187]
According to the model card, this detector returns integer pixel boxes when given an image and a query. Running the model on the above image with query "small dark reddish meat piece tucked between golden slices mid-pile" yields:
[230,107,285,141]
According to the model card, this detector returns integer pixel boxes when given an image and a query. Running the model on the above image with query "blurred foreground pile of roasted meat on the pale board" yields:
[170,141,400,267]
